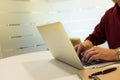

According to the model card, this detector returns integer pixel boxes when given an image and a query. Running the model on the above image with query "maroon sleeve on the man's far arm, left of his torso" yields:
[86,14,106,45]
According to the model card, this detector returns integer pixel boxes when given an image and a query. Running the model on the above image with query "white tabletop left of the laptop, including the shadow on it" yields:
[0,51,81,80]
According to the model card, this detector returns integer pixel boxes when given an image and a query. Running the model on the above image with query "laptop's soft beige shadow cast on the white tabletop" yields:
[23,59,78,80]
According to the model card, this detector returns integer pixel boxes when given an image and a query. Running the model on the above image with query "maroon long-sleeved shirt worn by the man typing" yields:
[86,4,120,49]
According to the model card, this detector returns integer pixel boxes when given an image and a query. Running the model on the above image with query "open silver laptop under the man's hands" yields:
[37,22,113,69]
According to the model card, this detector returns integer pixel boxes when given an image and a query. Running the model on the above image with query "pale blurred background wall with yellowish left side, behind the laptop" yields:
[0,0,113,57]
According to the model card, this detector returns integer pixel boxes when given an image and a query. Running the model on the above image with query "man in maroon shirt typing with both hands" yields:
[75,0,120,63]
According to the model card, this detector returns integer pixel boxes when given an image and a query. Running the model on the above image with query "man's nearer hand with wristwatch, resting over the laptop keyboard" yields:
[81,46,118,63]
